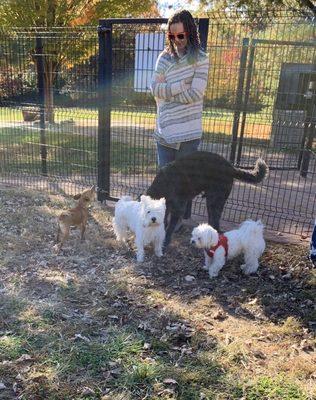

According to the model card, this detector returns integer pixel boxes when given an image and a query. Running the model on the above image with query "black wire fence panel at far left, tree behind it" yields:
[0,27,98,192]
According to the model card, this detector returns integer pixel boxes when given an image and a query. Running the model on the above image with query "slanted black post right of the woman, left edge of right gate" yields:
[229,38,249,163]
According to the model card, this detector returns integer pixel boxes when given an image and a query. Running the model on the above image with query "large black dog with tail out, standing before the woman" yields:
[147,151,268,247]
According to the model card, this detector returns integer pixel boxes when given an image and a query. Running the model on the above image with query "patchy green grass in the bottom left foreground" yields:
[0,300,238,400]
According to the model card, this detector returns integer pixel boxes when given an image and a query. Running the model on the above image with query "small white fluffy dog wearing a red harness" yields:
[191,220,265,278]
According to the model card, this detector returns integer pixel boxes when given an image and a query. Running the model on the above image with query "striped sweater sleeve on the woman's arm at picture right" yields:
[171,57,209,104]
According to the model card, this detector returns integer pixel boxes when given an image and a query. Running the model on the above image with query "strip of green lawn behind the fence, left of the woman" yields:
[0,128,156,175]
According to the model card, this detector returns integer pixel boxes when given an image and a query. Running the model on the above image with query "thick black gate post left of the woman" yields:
[98,19,112,201]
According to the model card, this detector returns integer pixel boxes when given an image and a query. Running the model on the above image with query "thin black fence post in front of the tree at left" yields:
[35,36,47,175]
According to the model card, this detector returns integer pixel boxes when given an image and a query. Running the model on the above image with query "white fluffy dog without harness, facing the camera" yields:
[113,195,166,262]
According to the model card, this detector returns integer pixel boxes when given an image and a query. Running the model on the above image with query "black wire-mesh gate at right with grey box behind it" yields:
[230,38,316,170]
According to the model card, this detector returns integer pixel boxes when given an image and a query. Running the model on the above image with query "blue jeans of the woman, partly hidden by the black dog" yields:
[157,139,201,219]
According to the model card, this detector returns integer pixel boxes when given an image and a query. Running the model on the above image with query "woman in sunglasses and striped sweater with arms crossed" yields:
[151,10,209,219]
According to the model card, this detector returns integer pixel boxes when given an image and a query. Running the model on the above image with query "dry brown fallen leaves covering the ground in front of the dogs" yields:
[0,188,316,399]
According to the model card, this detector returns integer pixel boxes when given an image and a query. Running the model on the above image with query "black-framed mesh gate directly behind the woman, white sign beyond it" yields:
[98,18,208,201]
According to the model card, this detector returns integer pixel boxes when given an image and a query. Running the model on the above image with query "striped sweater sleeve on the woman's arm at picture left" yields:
[151,53,188,100]
